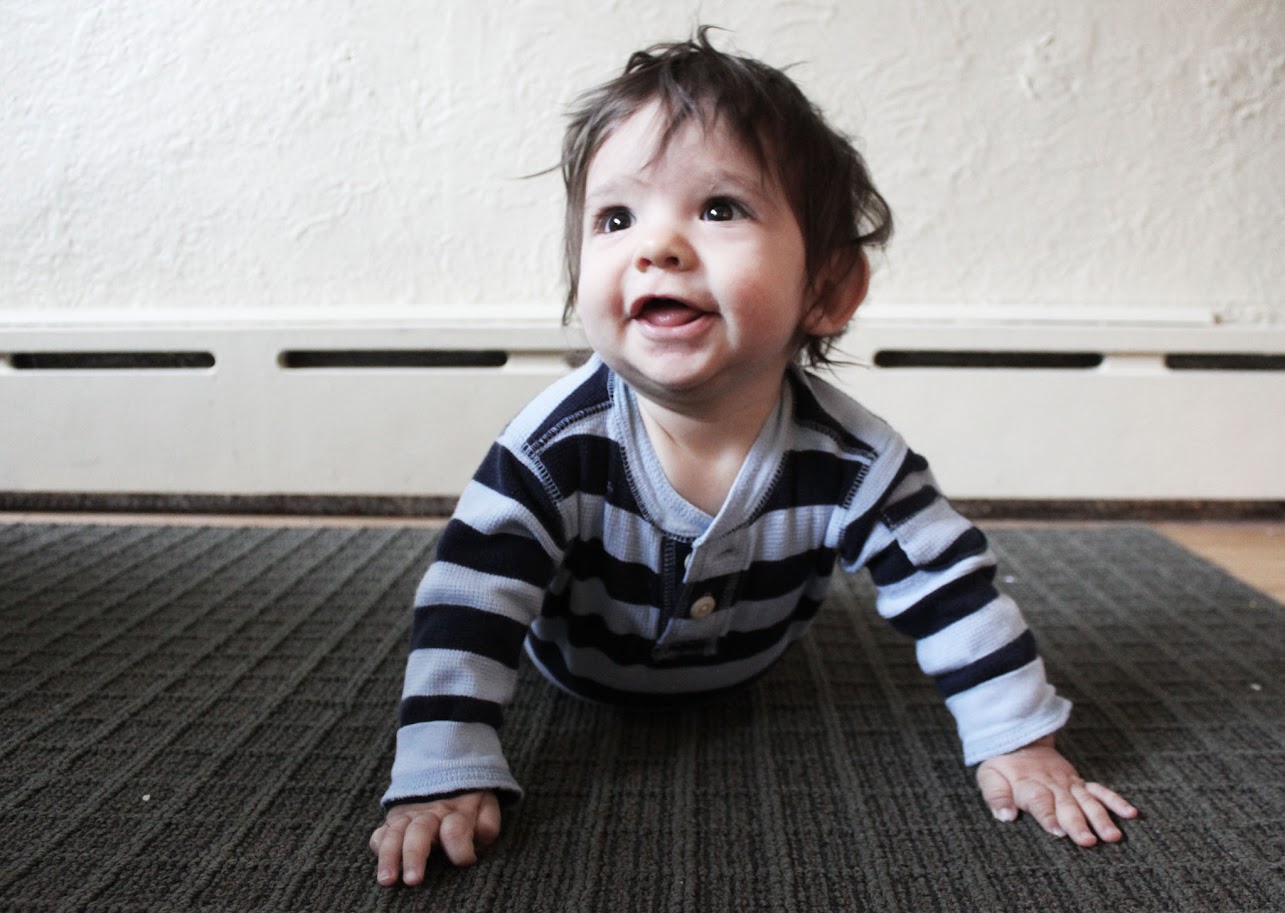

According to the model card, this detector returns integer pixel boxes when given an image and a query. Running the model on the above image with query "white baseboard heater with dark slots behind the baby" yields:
[0,307,1285,502]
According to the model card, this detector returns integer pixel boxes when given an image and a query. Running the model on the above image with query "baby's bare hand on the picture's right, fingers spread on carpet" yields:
[977,736,1137,846]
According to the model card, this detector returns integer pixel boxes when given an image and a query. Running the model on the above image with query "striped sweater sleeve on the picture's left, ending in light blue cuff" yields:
[382,443,564,806]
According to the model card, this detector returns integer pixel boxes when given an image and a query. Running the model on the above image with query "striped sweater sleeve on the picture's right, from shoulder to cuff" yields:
[840,451,1070,764]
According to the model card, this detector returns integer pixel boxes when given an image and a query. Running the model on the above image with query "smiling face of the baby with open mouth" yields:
[577,105,807,413]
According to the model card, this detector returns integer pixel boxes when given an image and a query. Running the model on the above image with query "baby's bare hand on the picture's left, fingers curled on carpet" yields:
[370,790,500,885]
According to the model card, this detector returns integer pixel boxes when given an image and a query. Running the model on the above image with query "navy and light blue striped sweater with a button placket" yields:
[383,358,1070,805]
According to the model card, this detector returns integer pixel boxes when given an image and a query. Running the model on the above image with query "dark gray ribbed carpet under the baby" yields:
[0,525,1285,913]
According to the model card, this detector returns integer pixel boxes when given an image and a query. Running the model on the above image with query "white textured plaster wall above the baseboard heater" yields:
[0,0,1285,324]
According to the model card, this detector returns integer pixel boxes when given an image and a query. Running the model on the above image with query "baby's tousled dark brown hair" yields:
[562,26,892,366]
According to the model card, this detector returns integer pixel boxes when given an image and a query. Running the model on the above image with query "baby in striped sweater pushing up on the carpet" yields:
[370,28,1137,885]
